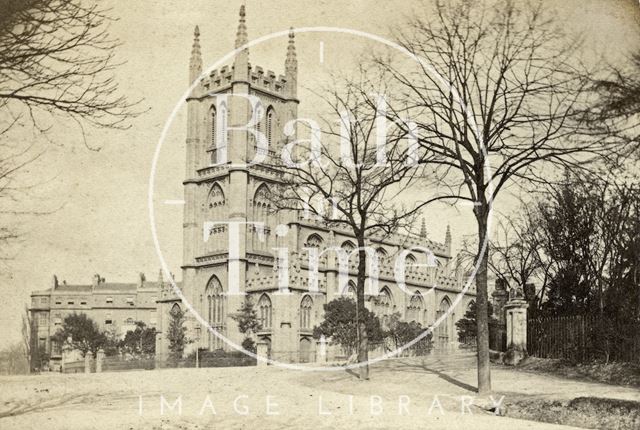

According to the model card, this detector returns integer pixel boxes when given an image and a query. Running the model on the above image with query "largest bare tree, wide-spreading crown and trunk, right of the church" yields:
[369,0,619,393]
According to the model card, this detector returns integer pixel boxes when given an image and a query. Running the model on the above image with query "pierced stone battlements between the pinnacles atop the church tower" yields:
[200,65,287,97]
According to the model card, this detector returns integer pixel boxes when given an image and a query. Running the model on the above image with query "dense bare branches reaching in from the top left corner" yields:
[0,0,139,134]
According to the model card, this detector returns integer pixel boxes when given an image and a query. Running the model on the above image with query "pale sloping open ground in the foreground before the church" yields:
[0,356,584,430]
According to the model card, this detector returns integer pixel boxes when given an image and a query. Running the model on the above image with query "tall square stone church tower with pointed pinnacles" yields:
[182,6,298,349]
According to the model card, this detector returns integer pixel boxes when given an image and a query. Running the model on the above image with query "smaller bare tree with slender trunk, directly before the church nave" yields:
[274,74,428,379]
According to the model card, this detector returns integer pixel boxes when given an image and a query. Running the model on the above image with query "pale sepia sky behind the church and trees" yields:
[0,0,640,348]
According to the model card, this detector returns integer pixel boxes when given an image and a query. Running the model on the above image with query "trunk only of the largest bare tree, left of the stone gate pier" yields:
[476,208,491,394]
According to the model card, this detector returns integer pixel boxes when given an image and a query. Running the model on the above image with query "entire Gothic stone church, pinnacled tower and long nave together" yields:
[156,6,475,362]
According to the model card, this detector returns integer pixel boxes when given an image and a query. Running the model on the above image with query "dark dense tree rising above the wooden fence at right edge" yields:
[536,175,640,318]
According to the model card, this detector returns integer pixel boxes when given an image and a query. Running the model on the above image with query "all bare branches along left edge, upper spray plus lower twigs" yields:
[0,0,139,255]
